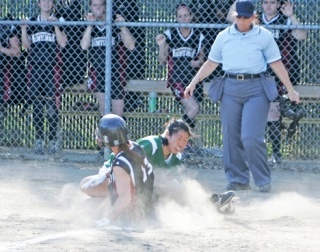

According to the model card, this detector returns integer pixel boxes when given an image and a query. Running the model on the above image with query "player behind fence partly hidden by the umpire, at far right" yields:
[228,0,307,164]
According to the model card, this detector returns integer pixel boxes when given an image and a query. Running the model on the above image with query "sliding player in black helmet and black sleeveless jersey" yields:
[80,114,154,225]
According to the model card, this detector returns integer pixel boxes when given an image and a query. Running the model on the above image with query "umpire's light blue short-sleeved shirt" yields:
[209,24,281,74]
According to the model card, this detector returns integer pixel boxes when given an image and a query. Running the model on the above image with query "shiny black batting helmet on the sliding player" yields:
[98,114,129,147]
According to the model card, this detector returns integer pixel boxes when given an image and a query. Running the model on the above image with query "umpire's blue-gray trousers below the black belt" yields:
[221,78,271,186]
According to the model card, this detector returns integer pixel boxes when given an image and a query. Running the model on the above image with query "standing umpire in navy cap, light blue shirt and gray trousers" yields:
[185,0,299,192]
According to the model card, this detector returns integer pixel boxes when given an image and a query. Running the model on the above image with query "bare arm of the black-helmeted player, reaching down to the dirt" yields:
[107,166,131,221]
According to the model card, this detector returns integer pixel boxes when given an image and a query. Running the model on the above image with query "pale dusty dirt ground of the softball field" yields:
[0,150,320,252]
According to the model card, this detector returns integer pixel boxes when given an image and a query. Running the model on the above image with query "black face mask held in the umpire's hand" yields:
[280,95,304,122]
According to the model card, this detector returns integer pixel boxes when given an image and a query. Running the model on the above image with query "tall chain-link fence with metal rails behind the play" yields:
[0,0,320,160]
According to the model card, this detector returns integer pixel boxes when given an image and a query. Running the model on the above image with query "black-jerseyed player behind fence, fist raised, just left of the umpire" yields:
[156,3,204,132]
